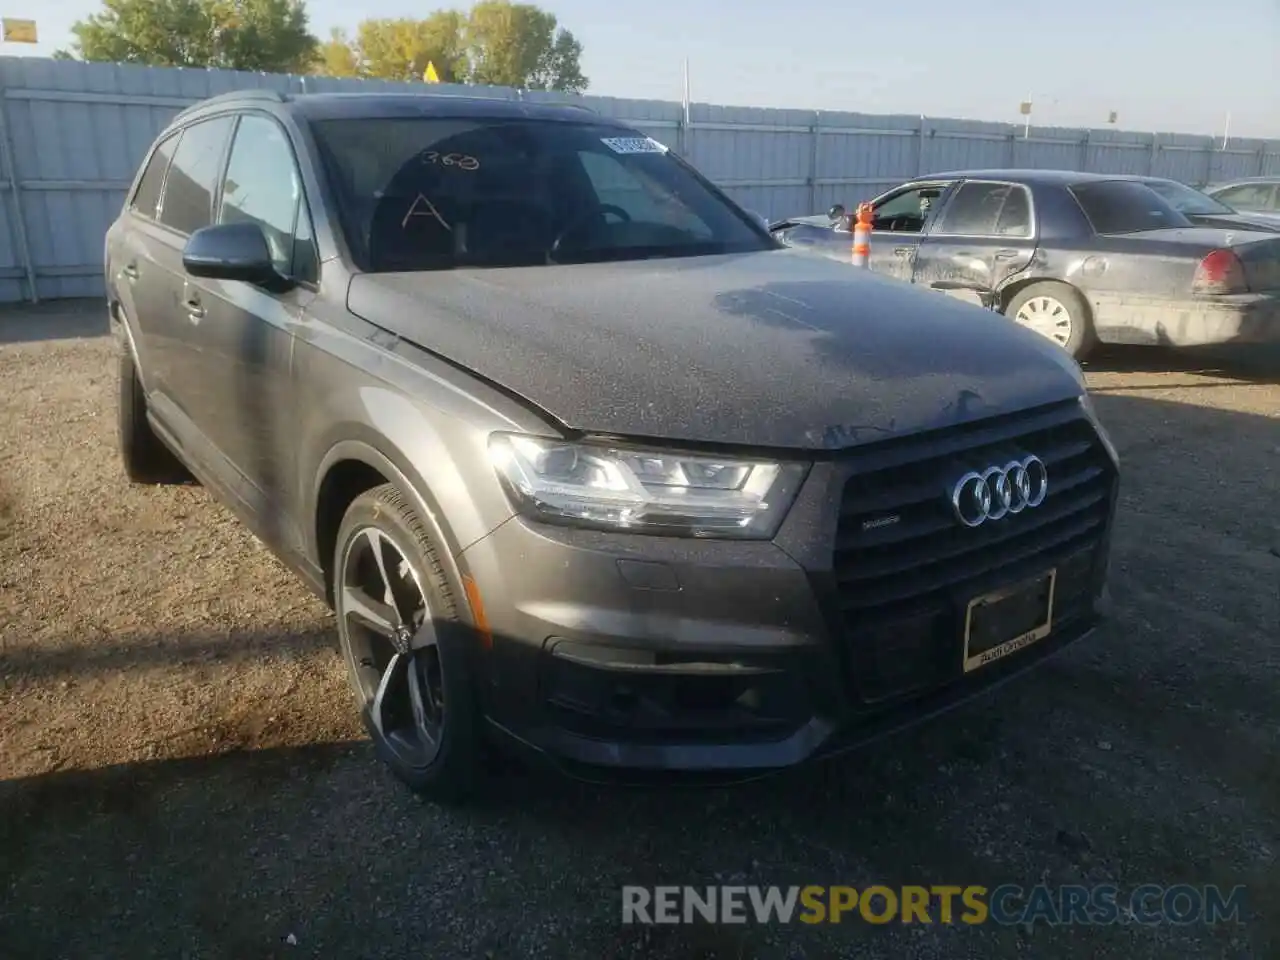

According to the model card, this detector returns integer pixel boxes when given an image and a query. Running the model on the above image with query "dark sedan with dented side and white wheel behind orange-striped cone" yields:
[771,169,1280,360]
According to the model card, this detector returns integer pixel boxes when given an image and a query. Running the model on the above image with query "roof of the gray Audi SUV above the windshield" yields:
[183,90,609,127]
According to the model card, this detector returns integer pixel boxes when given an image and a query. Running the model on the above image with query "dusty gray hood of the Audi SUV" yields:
[348,251,1082,449]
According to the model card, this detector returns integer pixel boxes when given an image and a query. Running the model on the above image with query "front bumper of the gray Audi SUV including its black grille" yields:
[462,404,1116,780]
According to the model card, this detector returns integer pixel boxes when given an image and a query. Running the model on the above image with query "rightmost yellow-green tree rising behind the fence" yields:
[466,0,586,93]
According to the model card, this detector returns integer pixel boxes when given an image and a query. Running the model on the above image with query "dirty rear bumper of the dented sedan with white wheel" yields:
[1091,293,1280,347]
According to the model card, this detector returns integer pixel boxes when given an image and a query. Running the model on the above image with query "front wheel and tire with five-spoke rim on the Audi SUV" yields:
[333,484,485,804]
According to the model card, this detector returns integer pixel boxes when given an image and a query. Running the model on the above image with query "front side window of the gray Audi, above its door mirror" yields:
[218,114,315,279]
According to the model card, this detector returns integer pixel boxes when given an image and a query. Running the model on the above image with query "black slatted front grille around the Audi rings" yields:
[833,402,1115,701]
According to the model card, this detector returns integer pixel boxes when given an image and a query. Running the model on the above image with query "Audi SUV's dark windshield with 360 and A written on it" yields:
[314,118,777,273]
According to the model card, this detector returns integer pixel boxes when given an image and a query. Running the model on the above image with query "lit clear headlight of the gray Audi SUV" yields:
[489,434,808,539]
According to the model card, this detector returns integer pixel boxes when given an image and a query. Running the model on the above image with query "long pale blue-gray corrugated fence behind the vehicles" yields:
[0,58,1280,302]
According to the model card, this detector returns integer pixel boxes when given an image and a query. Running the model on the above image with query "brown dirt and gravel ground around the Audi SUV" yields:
[0,305,1280,960]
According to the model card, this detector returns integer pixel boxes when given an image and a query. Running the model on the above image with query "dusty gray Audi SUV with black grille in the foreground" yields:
[106,91,1117,800]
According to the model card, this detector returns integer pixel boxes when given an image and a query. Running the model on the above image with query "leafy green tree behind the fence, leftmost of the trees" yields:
[60,0,316,73]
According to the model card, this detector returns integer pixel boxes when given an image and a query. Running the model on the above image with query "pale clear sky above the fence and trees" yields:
[10,0,1280,138]
